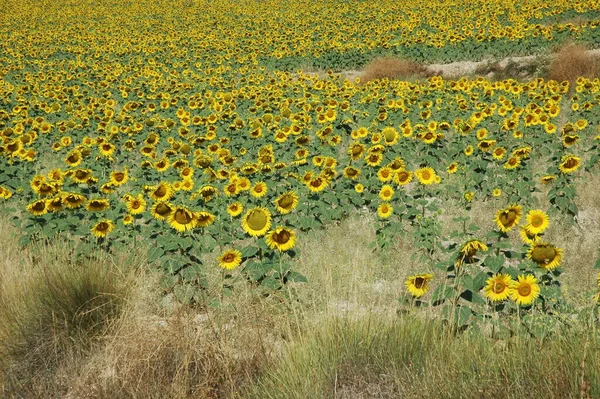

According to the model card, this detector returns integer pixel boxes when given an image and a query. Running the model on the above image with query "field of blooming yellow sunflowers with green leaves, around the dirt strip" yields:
[0,0,600,328]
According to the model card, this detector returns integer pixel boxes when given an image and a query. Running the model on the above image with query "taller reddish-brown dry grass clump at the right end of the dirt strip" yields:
[548,44,599,84]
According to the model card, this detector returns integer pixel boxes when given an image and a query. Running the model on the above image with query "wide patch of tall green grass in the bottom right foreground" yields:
[248,315,600,399]
